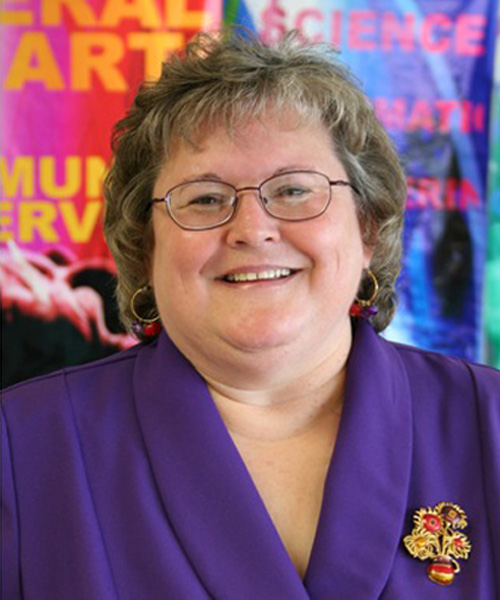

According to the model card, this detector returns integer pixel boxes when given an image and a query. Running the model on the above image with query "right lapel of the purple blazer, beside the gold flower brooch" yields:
[305,324,412,600]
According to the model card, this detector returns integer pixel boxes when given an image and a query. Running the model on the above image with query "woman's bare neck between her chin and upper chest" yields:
[173,321,352,440]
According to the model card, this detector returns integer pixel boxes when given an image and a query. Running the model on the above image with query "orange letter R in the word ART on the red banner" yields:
[71,32,127,92]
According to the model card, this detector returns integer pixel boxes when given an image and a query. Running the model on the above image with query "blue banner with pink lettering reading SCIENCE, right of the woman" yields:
[227,0,498,361]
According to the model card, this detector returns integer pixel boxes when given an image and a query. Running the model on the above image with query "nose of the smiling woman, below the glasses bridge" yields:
[227,188,280,246]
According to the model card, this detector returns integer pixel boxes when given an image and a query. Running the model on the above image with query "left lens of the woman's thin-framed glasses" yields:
[169,181,235,229]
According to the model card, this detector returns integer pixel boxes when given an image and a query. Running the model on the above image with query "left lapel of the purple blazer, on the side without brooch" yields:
[134,333,308,600]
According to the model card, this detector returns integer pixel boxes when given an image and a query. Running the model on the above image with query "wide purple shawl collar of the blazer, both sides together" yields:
[134,324,412,600]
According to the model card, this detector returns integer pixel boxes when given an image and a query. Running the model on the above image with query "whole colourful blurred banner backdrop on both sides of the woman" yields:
[0,0,500,386]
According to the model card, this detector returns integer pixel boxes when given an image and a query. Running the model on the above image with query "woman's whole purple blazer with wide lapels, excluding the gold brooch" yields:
[1,324,500,600]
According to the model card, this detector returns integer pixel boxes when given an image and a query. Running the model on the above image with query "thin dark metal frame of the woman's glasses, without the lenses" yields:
[151,169,359,231]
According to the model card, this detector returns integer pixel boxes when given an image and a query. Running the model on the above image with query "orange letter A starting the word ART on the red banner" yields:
[5,31,64,90]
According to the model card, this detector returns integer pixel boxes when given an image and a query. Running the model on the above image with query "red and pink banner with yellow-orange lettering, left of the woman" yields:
[0,0,222,385]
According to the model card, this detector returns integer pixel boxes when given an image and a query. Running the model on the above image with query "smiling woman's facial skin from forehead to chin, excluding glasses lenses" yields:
[151,115,371,382]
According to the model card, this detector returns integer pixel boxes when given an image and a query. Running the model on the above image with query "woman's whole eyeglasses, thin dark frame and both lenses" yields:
[151,171,357,231]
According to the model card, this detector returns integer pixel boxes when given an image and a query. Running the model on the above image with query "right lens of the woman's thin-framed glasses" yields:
[261,171,331,221]
